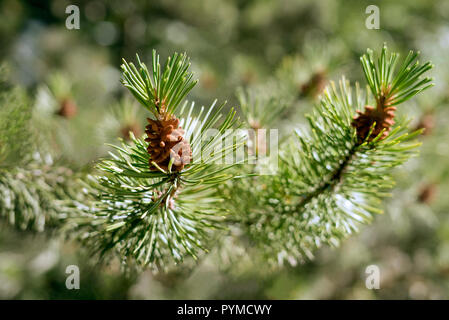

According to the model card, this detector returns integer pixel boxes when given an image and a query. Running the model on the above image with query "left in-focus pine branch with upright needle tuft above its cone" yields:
[68,53,242,270]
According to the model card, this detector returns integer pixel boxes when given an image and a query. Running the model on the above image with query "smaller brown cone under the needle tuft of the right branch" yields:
[352,106,396,143]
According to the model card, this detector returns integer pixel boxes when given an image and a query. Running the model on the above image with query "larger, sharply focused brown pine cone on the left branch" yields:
[145,117,192,171]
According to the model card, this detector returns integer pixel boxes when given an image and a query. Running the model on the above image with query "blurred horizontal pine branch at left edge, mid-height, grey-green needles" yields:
[0,162,79,232]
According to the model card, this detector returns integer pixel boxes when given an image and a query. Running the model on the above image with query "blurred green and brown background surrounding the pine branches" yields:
[0,0,449,299]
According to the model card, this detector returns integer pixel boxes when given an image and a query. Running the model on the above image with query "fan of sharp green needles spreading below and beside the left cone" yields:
[70,94,243,270]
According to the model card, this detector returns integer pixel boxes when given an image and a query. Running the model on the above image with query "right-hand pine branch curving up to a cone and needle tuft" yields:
[230,48,431,265]
